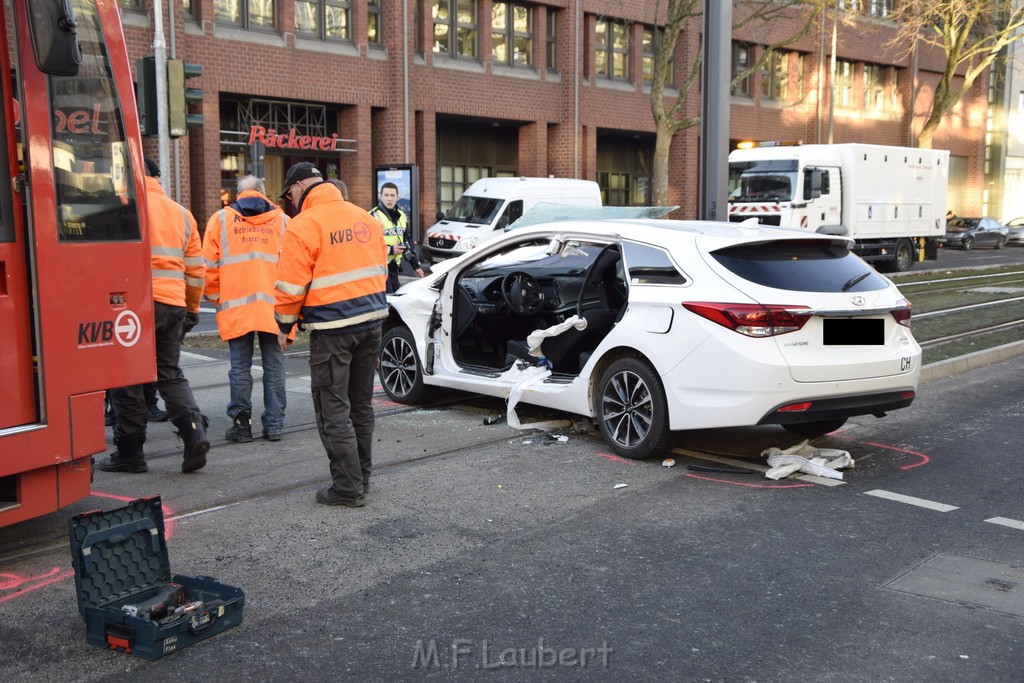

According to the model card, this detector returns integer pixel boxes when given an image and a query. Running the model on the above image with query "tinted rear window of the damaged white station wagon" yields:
[712,240,889,292]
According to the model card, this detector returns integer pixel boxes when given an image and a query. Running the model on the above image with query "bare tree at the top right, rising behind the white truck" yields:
[892,0,1024,148]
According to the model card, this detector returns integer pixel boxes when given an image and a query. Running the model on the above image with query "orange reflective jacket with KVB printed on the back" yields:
[274,182,387,333]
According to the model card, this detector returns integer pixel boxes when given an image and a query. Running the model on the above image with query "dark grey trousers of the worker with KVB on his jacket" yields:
[309,327,381,499]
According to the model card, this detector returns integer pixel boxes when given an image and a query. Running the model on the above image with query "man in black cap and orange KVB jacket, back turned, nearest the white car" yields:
[274,162,387,508]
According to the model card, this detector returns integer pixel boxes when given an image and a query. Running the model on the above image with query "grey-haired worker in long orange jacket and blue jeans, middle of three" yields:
[203,175,288,443]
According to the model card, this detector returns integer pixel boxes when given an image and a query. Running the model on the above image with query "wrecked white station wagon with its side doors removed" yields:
[380,220,921,459]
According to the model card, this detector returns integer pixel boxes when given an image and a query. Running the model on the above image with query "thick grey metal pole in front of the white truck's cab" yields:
[699,0,732,220]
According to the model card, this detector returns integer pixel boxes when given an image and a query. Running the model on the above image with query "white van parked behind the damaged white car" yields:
[423,178,601,261]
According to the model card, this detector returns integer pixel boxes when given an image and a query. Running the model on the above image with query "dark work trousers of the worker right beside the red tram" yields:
[111,301,200,440]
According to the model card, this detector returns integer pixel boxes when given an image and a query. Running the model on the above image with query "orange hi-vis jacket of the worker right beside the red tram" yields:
[145,177,206,313]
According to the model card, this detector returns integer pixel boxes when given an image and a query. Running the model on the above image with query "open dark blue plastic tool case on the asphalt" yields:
[68,496,246,659]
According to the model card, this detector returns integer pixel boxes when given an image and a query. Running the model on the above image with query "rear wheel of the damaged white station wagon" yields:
[596,357,672,460]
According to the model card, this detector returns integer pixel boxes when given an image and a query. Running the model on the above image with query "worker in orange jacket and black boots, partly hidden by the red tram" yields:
[97,159,210,473]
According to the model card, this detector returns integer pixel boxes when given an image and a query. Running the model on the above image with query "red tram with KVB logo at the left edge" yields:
[0,0,156,526]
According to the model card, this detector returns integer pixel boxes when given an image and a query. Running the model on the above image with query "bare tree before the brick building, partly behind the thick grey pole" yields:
[650,0,835,206]
